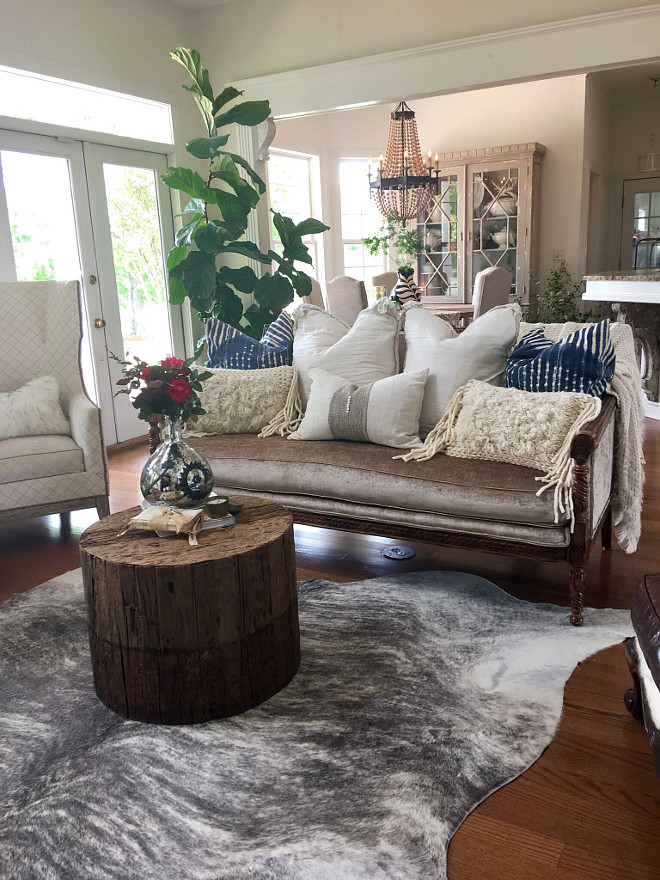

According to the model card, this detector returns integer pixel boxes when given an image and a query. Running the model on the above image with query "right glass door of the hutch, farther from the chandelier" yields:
[468,162,520,299]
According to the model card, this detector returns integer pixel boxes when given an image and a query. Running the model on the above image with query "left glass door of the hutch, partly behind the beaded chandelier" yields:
[417,168,465,302]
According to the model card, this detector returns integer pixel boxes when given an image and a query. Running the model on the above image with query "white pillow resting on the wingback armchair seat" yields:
[0,376,71,440]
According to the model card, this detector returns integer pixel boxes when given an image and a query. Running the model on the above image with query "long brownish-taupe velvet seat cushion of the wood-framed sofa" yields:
[195,434,568,527]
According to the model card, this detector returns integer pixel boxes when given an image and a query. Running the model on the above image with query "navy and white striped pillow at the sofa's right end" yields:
[505,321,616,397]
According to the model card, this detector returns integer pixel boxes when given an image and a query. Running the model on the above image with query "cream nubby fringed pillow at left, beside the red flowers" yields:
[185,367,298,437]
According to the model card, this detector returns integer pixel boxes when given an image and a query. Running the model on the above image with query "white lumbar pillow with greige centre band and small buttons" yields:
[289,368,428,449]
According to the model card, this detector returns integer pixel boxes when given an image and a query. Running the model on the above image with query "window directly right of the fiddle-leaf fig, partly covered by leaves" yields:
[268,150,323,280]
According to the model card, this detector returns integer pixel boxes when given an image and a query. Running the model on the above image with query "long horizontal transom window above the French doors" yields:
[0,67,174,144]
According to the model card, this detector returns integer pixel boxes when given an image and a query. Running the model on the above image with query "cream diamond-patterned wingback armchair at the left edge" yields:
[0,281,110,522]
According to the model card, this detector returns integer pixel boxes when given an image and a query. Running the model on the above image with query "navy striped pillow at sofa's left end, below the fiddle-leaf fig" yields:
[205,315,292,370]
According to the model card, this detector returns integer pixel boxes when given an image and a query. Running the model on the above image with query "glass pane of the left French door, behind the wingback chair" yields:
[0,150,98,401]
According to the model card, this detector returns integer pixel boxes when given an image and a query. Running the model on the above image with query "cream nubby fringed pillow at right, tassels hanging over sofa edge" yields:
[395,379,601,528]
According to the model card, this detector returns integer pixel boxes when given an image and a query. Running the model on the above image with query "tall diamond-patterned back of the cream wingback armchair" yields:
[0,281,82,401]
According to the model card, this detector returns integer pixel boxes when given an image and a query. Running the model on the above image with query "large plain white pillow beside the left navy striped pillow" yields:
[293,299,400,405]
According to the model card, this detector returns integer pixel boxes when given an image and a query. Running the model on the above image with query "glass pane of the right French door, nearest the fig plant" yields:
[103,164,173,363]
